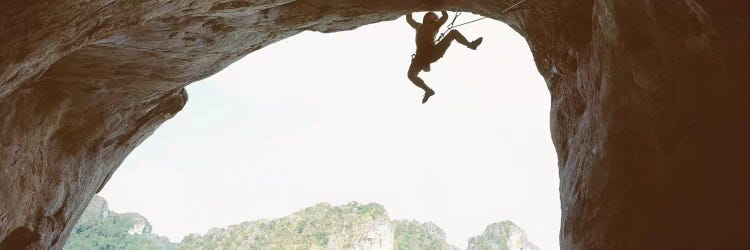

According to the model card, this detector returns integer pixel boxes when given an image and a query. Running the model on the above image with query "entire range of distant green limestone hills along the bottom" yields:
[65,196,538,250]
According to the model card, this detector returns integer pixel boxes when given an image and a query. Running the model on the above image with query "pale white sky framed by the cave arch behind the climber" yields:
[100,14,560,249]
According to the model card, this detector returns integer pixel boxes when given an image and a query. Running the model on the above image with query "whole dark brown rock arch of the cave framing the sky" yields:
[0,0,750,249]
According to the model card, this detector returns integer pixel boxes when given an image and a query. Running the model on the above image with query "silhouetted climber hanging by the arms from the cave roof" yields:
[406,11,482,103]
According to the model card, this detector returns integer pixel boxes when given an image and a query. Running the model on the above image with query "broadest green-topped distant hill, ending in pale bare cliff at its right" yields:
[177,202,390,249]
